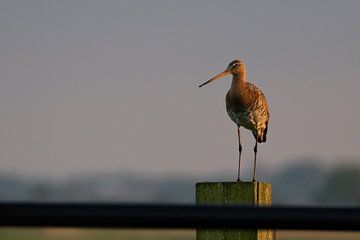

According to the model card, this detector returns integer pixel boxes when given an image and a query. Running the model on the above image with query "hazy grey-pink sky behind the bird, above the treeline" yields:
[0,0,360,178]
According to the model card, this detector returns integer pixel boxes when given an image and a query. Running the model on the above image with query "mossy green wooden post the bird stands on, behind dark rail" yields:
[196,182,274,240]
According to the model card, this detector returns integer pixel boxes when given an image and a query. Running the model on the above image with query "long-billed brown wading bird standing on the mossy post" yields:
[199,59,270,182]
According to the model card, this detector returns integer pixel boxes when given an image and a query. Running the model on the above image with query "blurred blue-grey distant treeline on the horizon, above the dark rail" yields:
[0,161,360,205]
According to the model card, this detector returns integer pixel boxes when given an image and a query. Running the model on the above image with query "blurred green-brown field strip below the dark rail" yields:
[0,228,360,240]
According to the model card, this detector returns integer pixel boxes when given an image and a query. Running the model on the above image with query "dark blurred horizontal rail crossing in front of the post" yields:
[0,203,360,231]
